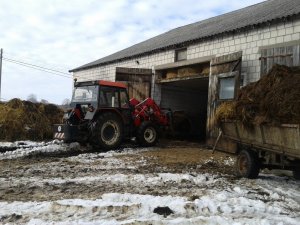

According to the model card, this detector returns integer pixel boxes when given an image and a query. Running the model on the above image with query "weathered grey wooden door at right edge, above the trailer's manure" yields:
[260,45,300,76]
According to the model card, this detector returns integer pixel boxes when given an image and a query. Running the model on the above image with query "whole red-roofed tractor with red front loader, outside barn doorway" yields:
[54,80,169,150]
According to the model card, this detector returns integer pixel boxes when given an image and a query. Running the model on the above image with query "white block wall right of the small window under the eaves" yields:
[187,20,300,85]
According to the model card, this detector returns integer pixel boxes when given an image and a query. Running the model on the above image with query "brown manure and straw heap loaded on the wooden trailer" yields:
[216,65,300,126]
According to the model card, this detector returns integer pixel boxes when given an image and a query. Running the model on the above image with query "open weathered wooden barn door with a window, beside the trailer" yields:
[206,52,242,151]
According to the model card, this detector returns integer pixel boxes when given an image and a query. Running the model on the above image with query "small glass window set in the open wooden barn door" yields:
[219,77,235,100]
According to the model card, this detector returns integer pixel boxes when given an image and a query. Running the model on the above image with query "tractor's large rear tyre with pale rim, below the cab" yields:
[93,113,123,150]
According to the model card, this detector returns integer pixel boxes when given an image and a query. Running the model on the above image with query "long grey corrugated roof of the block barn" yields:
[70,0,300,72]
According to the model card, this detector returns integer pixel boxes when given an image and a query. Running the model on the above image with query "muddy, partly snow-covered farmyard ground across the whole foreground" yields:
[0,140,300,225]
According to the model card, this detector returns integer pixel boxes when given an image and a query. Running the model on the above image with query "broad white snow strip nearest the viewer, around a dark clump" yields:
[0,187,300,225]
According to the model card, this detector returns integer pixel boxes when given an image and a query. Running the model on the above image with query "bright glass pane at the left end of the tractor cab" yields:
[72,86,99,103]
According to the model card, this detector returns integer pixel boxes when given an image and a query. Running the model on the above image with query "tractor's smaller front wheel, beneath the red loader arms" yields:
[137,121,159,147]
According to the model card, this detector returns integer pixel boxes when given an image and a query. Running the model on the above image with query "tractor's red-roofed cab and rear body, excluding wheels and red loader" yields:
[54,80,132,143]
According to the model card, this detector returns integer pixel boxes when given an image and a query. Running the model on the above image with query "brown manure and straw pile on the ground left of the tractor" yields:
[0,99,63,141]
